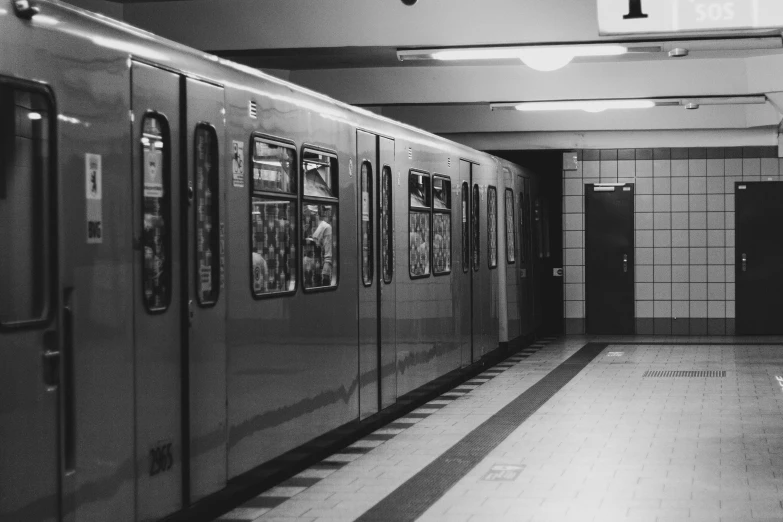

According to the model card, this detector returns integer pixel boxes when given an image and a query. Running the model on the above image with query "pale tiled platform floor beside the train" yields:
[219,337,783,522]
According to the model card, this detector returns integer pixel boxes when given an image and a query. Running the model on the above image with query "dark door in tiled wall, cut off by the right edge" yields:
[734,181,783,335]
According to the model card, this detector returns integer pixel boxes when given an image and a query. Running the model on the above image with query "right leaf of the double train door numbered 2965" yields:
[182,78,227,501]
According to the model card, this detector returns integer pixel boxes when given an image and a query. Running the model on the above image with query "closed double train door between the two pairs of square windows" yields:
[356,130,397,418]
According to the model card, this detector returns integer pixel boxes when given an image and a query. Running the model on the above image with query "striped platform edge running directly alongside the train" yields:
[217,338,555,522]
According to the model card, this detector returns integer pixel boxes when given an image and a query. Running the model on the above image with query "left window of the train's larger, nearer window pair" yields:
[250,135,297,297]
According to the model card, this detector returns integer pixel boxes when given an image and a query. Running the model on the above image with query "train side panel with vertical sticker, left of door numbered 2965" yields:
[0,8,134,520]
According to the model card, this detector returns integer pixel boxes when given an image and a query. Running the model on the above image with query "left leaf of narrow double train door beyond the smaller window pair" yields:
[454,160,473,366]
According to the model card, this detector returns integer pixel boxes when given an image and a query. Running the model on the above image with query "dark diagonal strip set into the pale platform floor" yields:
[357,343,608,522]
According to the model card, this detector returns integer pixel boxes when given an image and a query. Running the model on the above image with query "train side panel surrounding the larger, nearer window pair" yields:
[225,82,358,478]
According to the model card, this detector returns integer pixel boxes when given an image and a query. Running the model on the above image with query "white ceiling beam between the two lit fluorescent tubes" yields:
[290,59,752,105]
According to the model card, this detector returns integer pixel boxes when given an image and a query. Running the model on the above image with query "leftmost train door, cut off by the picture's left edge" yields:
[0,77,60,522]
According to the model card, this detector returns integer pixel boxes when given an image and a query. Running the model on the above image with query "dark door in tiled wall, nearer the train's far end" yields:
[585,183,636,334]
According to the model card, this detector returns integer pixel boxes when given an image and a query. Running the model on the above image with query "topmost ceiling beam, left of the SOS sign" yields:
[125,0,598,50]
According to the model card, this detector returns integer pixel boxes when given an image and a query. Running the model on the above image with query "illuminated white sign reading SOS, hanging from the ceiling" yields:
[597,0,783,35]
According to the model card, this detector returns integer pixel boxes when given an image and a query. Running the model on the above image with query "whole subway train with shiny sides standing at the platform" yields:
[0,1,546,522]
